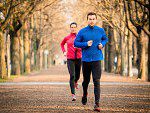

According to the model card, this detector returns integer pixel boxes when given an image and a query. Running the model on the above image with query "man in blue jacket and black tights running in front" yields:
[74,12,108,112]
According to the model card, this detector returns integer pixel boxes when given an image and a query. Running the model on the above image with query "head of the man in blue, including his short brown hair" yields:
[87,12,97,27]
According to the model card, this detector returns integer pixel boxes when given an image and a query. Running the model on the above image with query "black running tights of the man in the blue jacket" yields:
[82,61,101,103]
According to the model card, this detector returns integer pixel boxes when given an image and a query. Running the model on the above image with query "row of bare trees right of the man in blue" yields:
[76,0,150,81]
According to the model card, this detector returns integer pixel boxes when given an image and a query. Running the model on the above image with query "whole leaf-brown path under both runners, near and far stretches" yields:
[0,66,150,113]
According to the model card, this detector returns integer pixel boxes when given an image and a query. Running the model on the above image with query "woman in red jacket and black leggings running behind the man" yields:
[61,22,82,101]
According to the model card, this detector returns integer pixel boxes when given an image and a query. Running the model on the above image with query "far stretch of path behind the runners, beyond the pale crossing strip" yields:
[11,65,149,84]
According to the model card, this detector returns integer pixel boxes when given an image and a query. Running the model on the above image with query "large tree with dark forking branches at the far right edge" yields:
[123,0,150,80]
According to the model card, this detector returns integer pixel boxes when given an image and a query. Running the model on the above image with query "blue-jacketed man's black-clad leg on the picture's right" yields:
[92,61,101,108]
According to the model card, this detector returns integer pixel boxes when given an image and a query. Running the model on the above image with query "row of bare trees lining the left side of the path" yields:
[0,0,62,78]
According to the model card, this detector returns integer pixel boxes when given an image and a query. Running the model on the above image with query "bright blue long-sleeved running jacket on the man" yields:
[74,26,108,62]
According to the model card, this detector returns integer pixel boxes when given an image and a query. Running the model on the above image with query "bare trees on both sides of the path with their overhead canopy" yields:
[0,0,150,80]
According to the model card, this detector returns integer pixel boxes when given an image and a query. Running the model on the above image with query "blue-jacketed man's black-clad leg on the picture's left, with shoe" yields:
[82,62,91,105]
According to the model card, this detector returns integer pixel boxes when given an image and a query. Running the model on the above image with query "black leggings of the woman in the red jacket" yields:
[67,59,81,94]
